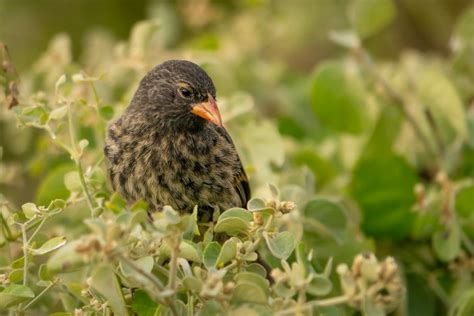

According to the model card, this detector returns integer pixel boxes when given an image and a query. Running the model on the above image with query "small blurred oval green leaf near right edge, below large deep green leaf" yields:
[432,222,461,261]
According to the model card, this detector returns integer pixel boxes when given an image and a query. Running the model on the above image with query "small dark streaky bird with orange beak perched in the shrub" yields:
[104,60,250,215]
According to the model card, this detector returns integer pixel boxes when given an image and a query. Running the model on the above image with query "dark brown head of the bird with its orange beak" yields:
[131,60,222,128]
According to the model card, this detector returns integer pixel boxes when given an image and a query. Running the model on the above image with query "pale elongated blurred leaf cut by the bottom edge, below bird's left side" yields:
[92,265,127,315]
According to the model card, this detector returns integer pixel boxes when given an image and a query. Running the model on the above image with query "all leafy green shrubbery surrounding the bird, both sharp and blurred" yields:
[0,0,474,315]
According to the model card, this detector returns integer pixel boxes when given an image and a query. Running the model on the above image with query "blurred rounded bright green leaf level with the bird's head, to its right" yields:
[311,62,367,134]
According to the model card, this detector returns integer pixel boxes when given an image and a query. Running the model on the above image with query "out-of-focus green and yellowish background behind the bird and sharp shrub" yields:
[0,0,474,315]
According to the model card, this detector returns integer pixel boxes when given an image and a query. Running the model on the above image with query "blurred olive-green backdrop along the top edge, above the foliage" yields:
[0,0,472,71]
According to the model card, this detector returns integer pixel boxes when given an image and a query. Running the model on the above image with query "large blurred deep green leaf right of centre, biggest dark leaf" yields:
[351,154,418,238]
